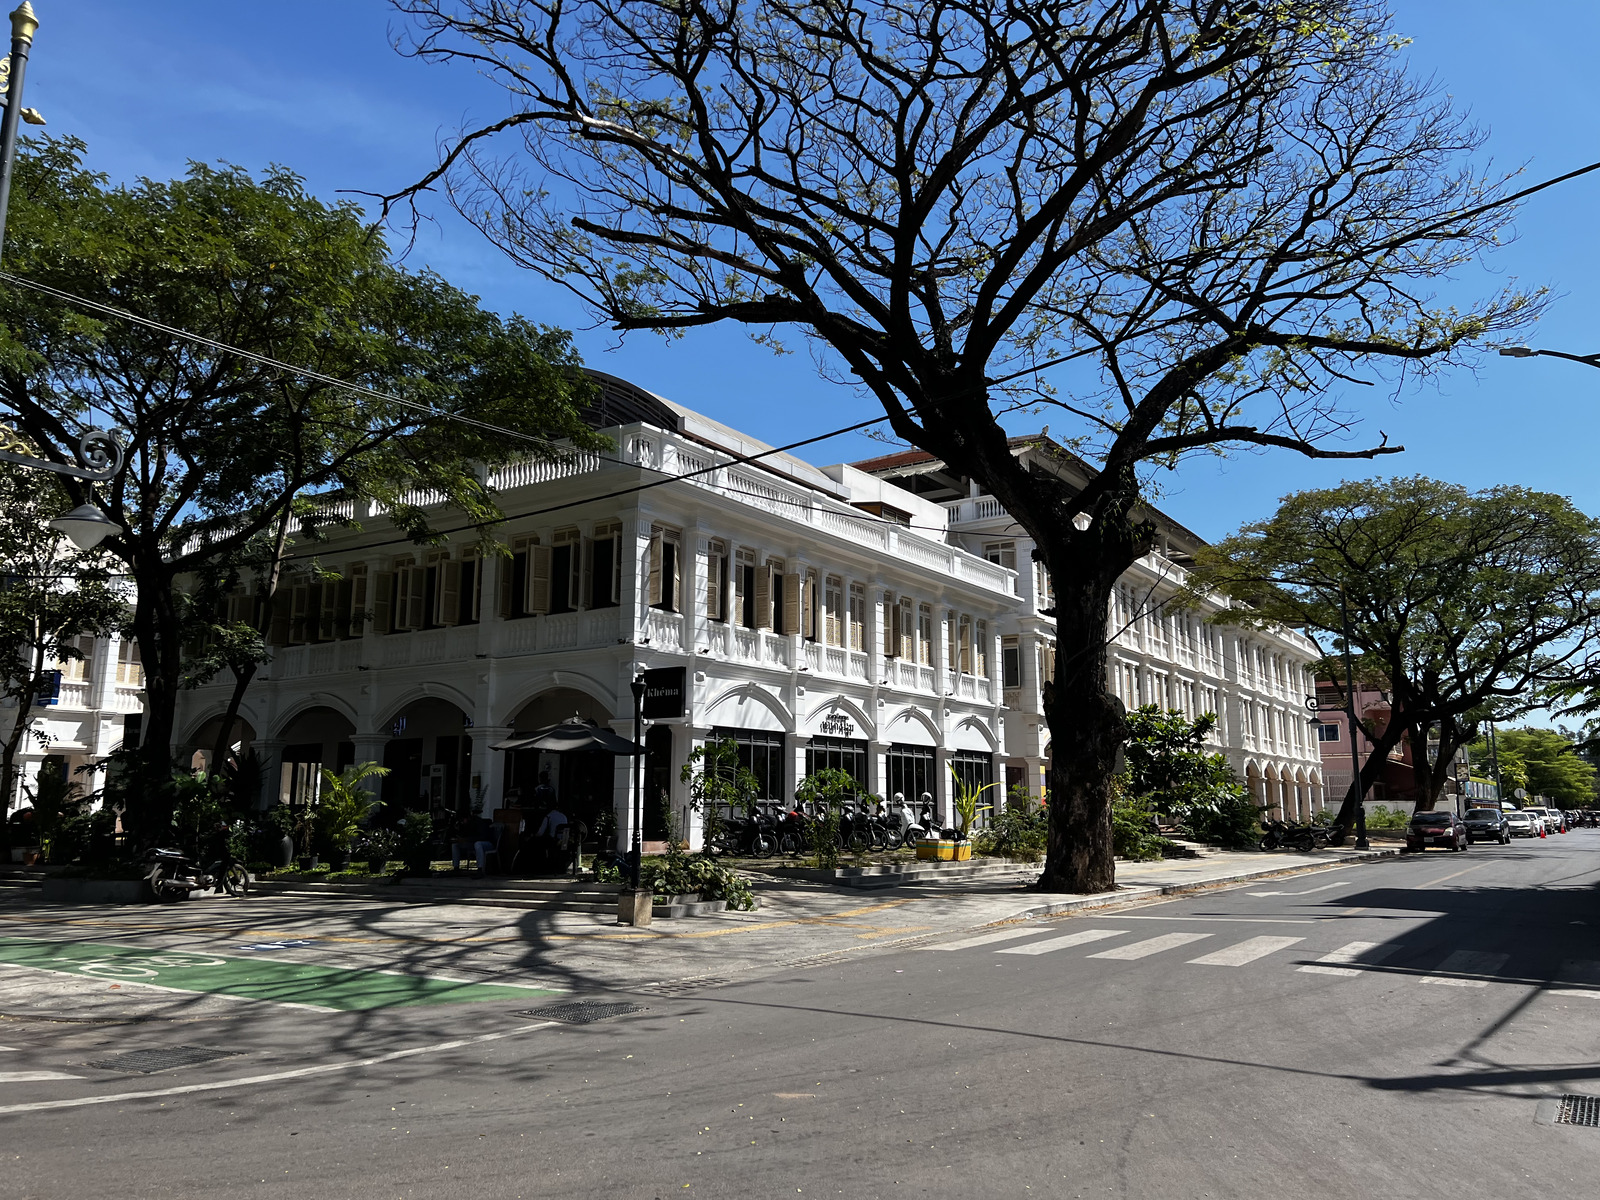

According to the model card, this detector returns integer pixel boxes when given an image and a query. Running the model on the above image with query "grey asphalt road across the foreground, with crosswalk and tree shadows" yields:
[0,830,1600,1200]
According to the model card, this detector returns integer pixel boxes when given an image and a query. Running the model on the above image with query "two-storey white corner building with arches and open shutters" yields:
[178,376,1024,837]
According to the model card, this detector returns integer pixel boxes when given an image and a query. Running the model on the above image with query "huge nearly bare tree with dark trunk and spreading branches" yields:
[386,0,1561,891]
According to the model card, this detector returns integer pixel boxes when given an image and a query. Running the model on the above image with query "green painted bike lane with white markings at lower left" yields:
[0,938,557,1013]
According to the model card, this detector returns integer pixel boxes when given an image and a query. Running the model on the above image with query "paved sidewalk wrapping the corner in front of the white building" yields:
[0,850,1394,1014]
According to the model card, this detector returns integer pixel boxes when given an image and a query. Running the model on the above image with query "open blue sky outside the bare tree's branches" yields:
[27,0,1600,538]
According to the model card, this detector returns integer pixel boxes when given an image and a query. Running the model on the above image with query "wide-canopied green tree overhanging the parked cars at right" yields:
[1190,477,1600,826]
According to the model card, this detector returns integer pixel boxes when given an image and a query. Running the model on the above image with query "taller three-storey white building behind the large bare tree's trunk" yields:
[856,435,1323,819]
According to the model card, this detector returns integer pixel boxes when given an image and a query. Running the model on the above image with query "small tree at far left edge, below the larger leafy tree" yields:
[0,462,126,848]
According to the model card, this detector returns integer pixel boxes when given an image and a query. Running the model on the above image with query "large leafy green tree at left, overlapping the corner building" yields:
[0,139,597,829]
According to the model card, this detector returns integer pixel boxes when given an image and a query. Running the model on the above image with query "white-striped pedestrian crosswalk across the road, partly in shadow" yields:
[928,925,1600,1000]
